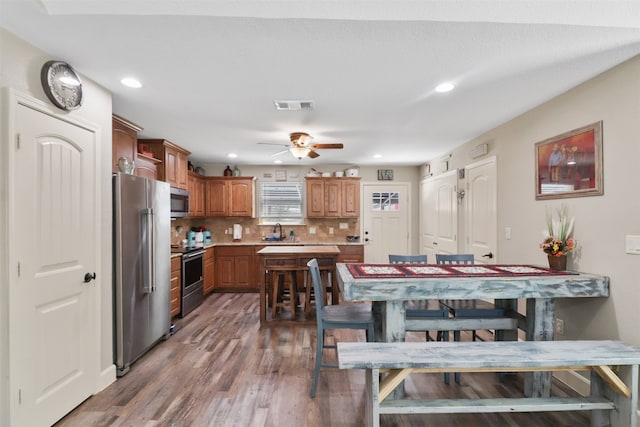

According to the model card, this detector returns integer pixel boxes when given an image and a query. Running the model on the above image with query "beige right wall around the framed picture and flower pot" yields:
[424,57,640,345]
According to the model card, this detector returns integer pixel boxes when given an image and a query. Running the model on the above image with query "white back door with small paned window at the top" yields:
[361,183,411,263]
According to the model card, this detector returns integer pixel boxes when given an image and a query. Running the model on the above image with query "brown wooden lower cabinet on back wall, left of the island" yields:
[214,246,258,292]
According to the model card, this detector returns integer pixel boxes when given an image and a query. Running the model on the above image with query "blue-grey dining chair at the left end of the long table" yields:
[307,258,374,397]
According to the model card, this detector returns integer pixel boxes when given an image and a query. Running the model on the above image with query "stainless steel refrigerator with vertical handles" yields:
[113,173,171,376]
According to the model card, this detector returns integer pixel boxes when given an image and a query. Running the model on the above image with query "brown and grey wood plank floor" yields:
[56,294,589,427]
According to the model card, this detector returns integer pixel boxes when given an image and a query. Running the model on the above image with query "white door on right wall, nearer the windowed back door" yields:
[420,170,458,262]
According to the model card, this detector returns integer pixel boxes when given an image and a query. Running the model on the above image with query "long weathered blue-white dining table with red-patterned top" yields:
[336,263,609,397]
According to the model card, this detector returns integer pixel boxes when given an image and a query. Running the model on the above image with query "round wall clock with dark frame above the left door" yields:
[40,61,82,111]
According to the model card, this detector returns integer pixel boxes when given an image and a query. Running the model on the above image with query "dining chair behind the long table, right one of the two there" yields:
[436,254,504,383]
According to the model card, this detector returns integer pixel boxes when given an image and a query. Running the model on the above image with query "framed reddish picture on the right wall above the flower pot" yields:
[535,121,603,200]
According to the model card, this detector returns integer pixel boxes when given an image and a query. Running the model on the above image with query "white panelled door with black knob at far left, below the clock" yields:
[9,102,99,426]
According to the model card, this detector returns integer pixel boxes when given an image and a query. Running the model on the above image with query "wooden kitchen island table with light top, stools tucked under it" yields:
[256,245,340,324]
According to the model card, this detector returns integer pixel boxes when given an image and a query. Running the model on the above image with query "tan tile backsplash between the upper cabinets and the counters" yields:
[171,217,362,244]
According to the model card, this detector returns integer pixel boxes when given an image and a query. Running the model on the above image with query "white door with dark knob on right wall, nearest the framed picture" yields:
[465,157,498,264]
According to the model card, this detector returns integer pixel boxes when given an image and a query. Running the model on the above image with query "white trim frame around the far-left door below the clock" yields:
[0,87,102,425]
